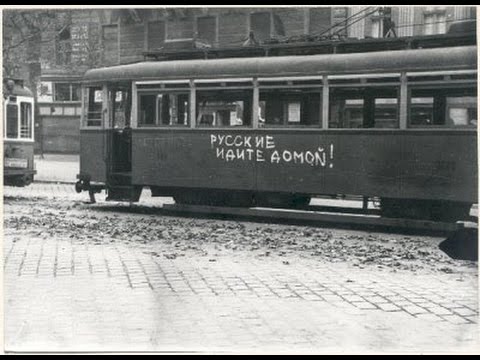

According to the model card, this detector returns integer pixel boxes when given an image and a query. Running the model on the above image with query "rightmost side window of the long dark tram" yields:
[410,88,477,127]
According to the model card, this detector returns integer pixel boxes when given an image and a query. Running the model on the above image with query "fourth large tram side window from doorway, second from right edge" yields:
[328,87,399,128]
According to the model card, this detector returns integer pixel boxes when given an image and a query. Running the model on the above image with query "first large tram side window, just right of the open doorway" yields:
[138,92,190,126]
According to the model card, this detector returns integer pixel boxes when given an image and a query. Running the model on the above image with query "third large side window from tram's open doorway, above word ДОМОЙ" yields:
[258,85,324,128]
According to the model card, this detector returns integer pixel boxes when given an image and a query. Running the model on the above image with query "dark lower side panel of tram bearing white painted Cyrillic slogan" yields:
[132,130,477,203]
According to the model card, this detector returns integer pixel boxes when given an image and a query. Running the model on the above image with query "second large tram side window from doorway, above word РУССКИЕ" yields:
[196,89,253,127]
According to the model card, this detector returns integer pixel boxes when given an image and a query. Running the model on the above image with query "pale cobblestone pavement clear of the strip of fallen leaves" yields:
[4,184,479,353]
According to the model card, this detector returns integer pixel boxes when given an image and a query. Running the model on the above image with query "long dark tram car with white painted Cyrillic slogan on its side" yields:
[77,42,478,220]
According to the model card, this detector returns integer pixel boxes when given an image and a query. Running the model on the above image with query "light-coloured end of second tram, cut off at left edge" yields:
[3,79,36,186]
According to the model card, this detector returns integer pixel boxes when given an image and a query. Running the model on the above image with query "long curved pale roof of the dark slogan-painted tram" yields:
[84,46,477,83]
